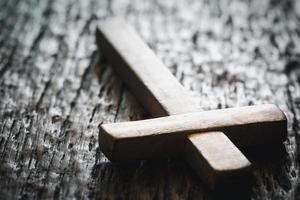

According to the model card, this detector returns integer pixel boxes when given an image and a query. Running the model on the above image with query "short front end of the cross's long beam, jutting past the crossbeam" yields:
[184,131,251,189]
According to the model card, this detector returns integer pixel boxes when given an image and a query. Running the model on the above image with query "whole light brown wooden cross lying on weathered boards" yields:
[96,18,287,189]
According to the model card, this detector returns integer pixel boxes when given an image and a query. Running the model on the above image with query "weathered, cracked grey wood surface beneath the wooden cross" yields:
[0,0,300,199]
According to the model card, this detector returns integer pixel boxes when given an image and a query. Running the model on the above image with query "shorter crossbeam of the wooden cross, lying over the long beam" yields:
[99,104,287,160]
